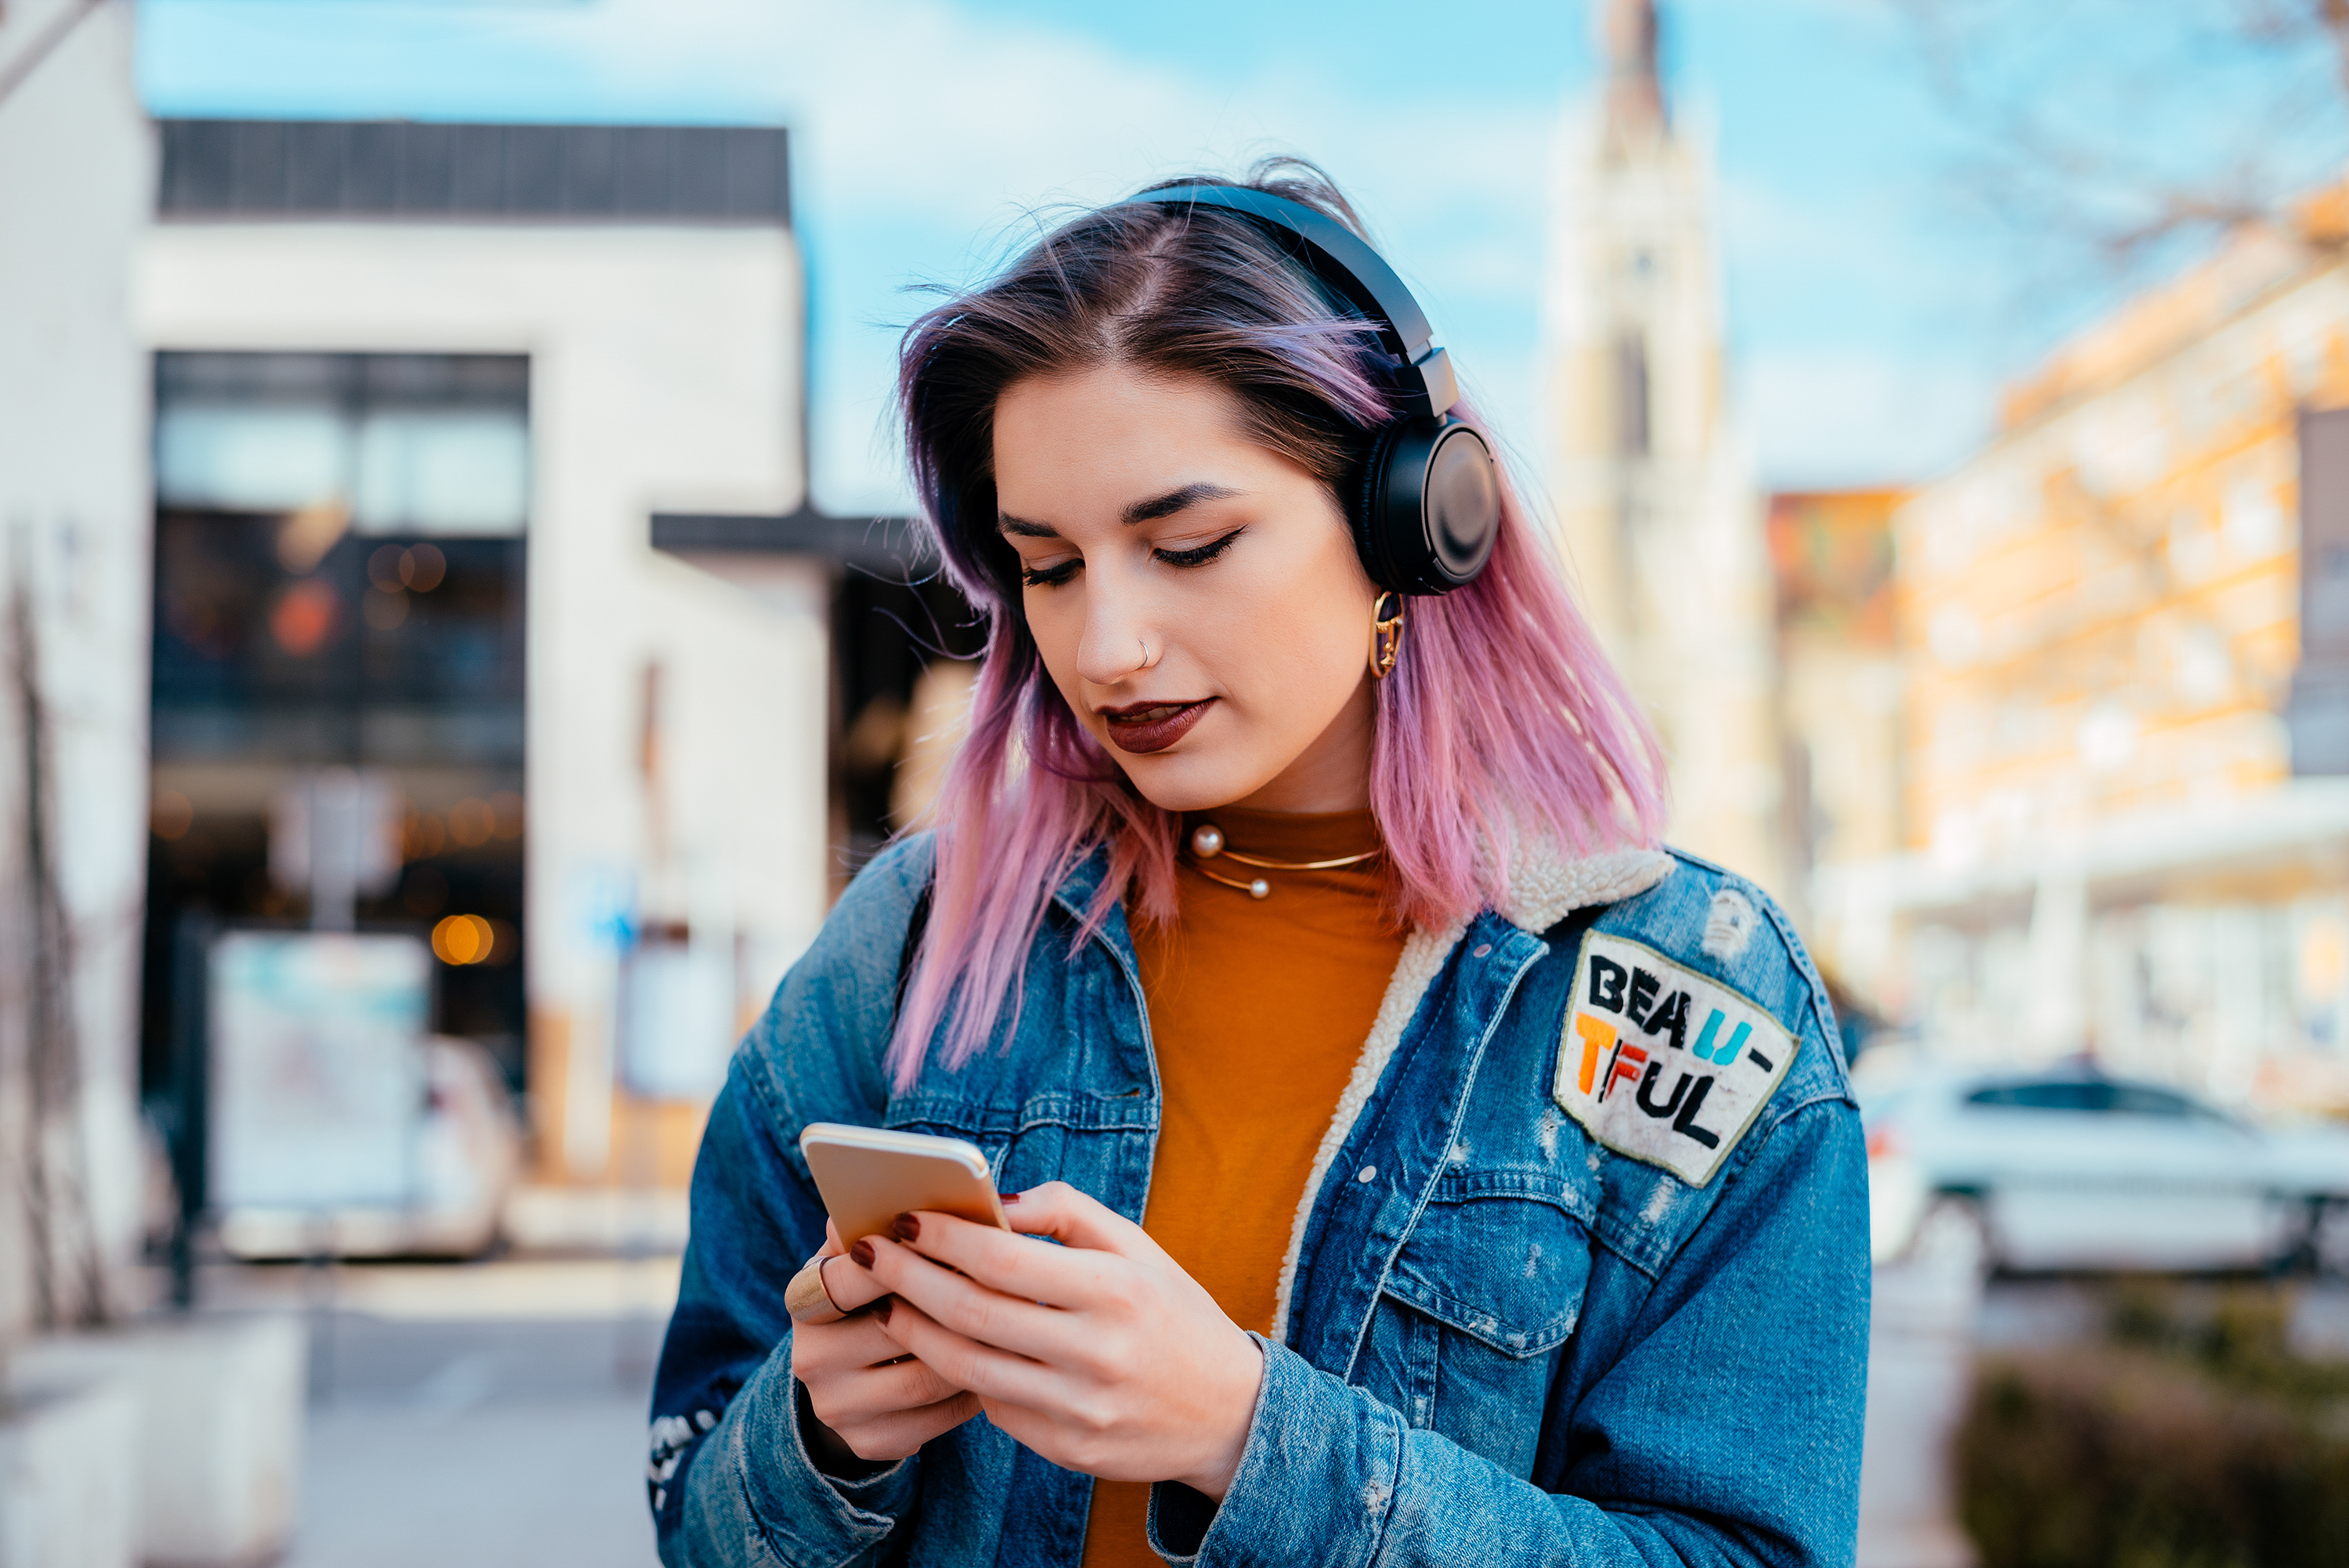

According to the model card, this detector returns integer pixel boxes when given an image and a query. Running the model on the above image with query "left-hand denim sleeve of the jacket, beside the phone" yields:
[648,840,928,1568]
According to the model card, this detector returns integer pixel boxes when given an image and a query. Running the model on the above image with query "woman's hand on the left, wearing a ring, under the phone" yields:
[792,1223,980,1474]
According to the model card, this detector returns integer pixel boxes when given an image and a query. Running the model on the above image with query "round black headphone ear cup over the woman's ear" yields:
[1355,416,1501,594]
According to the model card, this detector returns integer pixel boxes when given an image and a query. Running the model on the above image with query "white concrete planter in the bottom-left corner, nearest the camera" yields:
[0,1371,139,1568]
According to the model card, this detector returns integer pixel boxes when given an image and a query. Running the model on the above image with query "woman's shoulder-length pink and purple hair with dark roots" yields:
[888,160,1663,1087]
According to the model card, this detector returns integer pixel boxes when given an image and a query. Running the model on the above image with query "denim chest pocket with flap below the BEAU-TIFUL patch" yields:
[1360,1171,1590,1476]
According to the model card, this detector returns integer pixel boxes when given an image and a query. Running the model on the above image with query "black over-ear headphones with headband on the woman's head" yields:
[1135,186,1501,594]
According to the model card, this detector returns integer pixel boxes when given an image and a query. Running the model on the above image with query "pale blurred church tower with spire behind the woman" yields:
[1543,0,1790,889]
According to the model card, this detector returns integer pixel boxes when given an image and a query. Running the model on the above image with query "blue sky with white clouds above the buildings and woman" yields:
[139,0,2095,512]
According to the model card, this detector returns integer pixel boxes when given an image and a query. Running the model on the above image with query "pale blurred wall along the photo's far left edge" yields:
[0,0,155,1345]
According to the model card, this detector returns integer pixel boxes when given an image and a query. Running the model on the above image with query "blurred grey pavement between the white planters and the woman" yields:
[202,1256,679,1568]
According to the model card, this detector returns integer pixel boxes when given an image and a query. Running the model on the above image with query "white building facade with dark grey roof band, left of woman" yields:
[134,122,829,1181]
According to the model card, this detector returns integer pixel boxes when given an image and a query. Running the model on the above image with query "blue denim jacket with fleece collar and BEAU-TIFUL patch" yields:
[648,838,1867,1568]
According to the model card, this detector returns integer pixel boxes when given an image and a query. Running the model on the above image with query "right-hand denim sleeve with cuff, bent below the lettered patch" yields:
[1174,1101,1870,1568]
